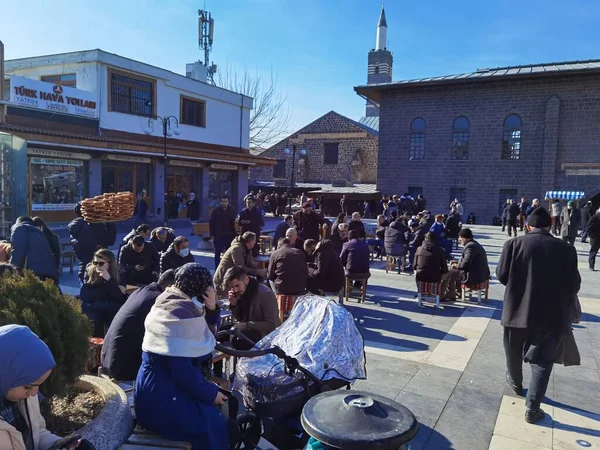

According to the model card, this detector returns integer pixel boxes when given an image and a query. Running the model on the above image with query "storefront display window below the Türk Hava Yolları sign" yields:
[27,148,91,222]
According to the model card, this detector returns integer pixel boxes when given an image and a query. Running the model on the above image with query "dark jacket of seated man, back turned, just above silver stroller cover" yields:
[268,244,308,295]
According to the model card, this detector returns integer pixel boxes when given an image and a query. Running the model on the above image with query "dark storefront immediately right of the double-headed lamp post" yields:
[167,159,204,218]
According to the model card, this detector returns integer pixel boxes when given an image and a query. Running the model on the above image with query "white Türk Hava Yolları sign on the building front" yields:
[10,75,98,118]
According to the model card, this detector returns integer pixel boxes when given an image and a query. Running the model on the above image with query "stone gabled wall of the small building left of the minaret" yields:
[250,111,378,183]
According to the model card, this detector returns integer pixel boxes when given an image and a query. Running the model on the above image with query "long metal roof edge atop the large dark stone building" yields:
[354,59,600,101]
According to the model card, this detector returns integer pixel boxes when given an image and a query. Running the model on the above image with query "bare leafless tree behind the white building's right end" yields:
[215,65,291,148]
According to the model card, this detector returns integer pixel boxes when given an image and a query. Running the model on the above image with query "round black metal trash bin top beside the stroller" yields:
[302,390,419,450]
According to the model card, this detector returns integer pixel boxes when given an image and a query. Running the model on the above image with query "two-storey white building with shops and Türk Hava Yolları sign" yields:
[0,50,271,229]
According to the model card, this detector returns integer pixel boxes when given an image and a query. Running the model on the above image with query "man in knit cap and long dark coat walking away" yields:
[496,207,581,423]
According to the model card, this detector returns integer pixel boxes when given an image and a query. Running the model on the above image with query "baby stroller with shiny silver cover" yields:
[217,295,366,450]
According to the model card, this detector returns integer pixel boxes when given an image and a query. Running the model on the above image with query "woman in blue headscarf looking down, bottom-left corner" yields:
[0,325,79,450]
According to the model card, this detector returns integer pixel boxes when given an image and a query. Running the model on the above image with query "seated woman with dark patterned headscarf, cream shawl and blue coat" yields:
[135,263,229,450]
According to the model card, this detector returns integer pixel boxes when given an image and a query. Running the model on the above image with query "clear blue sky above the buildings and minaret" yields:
[0,0,600,141]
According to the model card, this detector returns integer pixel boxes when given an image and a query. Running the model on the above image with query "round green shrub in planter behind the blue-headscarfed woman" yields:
[0,271,91,396]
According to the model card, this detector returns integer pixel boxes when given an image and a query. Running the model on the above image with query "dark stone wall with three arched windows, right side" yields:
[377,75,600,224]
